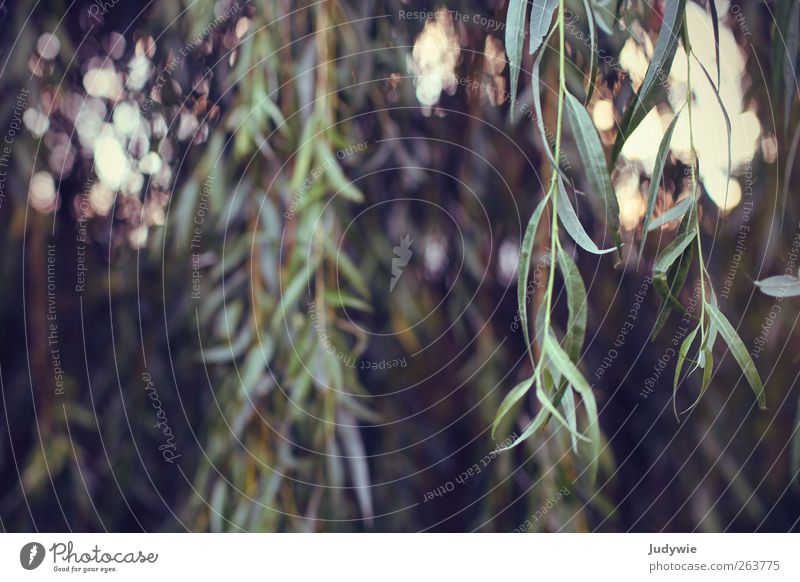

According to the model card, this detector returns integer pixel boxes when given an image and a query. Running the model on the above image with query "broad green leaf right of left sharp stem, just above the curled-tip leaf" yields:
[565,92,622,248]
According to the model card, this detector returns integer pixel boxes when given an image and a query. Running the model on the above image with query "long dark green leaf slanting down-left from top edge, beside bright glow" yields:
[611,0,686,165]
